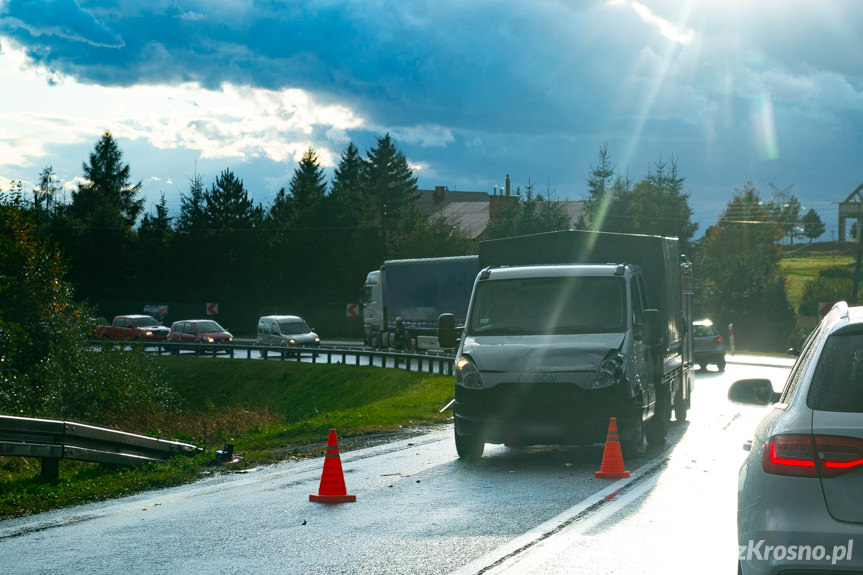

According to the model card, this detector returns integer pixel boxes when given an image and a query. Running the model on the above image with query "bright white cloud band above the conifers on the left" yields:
[0,43,365,173]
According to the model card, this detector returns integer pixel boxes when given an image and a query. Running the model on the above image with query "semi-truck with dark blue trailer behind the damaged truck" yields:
[360,255,479,349]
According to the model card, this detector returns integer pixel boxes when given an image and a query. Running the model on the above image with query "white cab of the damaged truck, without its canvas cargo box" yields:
[454,264,662,456]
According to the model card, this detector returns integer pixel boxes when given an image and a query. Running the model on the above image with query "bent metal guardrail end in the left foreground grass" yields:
[0,415,201,481]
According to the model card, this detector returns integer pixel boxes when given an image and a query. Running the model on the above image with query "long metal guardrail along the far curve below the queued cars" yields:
[93,340,454,375]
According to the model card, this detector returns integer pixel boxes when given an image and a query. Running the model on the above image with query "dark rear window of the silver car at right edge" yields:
[807,330,863,413]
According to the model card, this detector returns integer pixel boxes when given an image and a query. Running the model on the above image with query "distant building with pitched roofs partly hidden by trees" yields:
[419,186,584,239]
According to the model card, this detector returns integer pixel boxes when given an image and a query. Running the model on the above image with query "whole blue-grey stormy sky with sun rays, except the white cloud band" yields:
[0,0,863,234]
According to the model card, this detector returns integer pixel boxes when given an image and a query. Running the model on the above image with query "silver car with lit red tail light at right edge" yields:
[728,302,863,574]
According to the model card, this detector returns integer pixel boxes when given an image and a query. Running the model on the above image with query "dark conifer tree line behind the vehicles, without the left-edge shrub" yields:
[3,132,823,352]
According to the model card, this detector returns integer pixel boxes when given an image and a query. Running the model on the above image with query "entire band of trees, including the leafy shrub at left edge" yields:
[0,132,836,429]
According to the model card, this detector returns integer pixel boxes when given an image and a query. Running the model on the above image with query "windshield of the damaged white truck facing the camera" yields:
[467,277,626,335]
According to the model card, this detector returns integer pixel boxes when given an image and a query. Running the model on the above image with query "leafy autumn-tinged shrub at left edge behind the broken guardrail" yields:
[0,194,173,427]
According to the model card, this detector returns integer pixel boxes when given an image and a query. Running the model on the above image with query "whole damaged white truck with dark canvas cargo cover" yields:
[440,231,693,459]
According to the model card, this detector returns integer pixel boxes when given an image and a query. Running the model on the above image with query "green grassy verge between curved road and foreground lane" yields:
[0,356,453,519]
